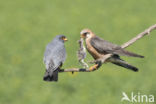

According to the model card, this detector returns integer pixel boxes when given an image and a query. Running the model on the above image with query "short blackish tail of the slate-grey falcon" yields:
[43,69,58,81]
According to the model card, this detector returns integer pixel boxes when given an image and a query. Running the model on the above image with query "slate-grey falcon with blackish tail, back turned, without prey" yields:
[43,35,67,81]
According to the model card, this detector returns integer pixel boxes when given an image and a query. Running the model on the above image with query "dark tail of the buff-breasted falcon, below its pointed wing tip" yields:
[112,59,139,72]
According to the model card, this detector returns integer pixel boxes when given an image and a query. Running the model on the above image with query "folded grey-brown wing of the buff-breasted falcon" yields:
[90,36,144,58]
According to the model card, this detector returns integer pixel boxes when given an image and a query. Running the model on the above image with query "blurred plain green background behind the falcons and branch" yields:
[0,0,156,104]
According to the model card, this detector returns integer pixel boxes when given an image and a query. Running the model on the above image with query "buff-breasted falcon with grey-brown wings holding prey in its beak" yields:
[80,29,144,71]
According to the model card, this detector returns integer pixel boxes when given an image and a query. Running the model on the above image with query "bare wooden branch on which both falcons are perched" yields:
[59,24,156,72]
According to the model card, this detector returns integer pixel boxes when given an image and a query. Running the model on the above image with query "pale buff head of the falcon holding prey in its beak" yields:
[80,29,94,39]
